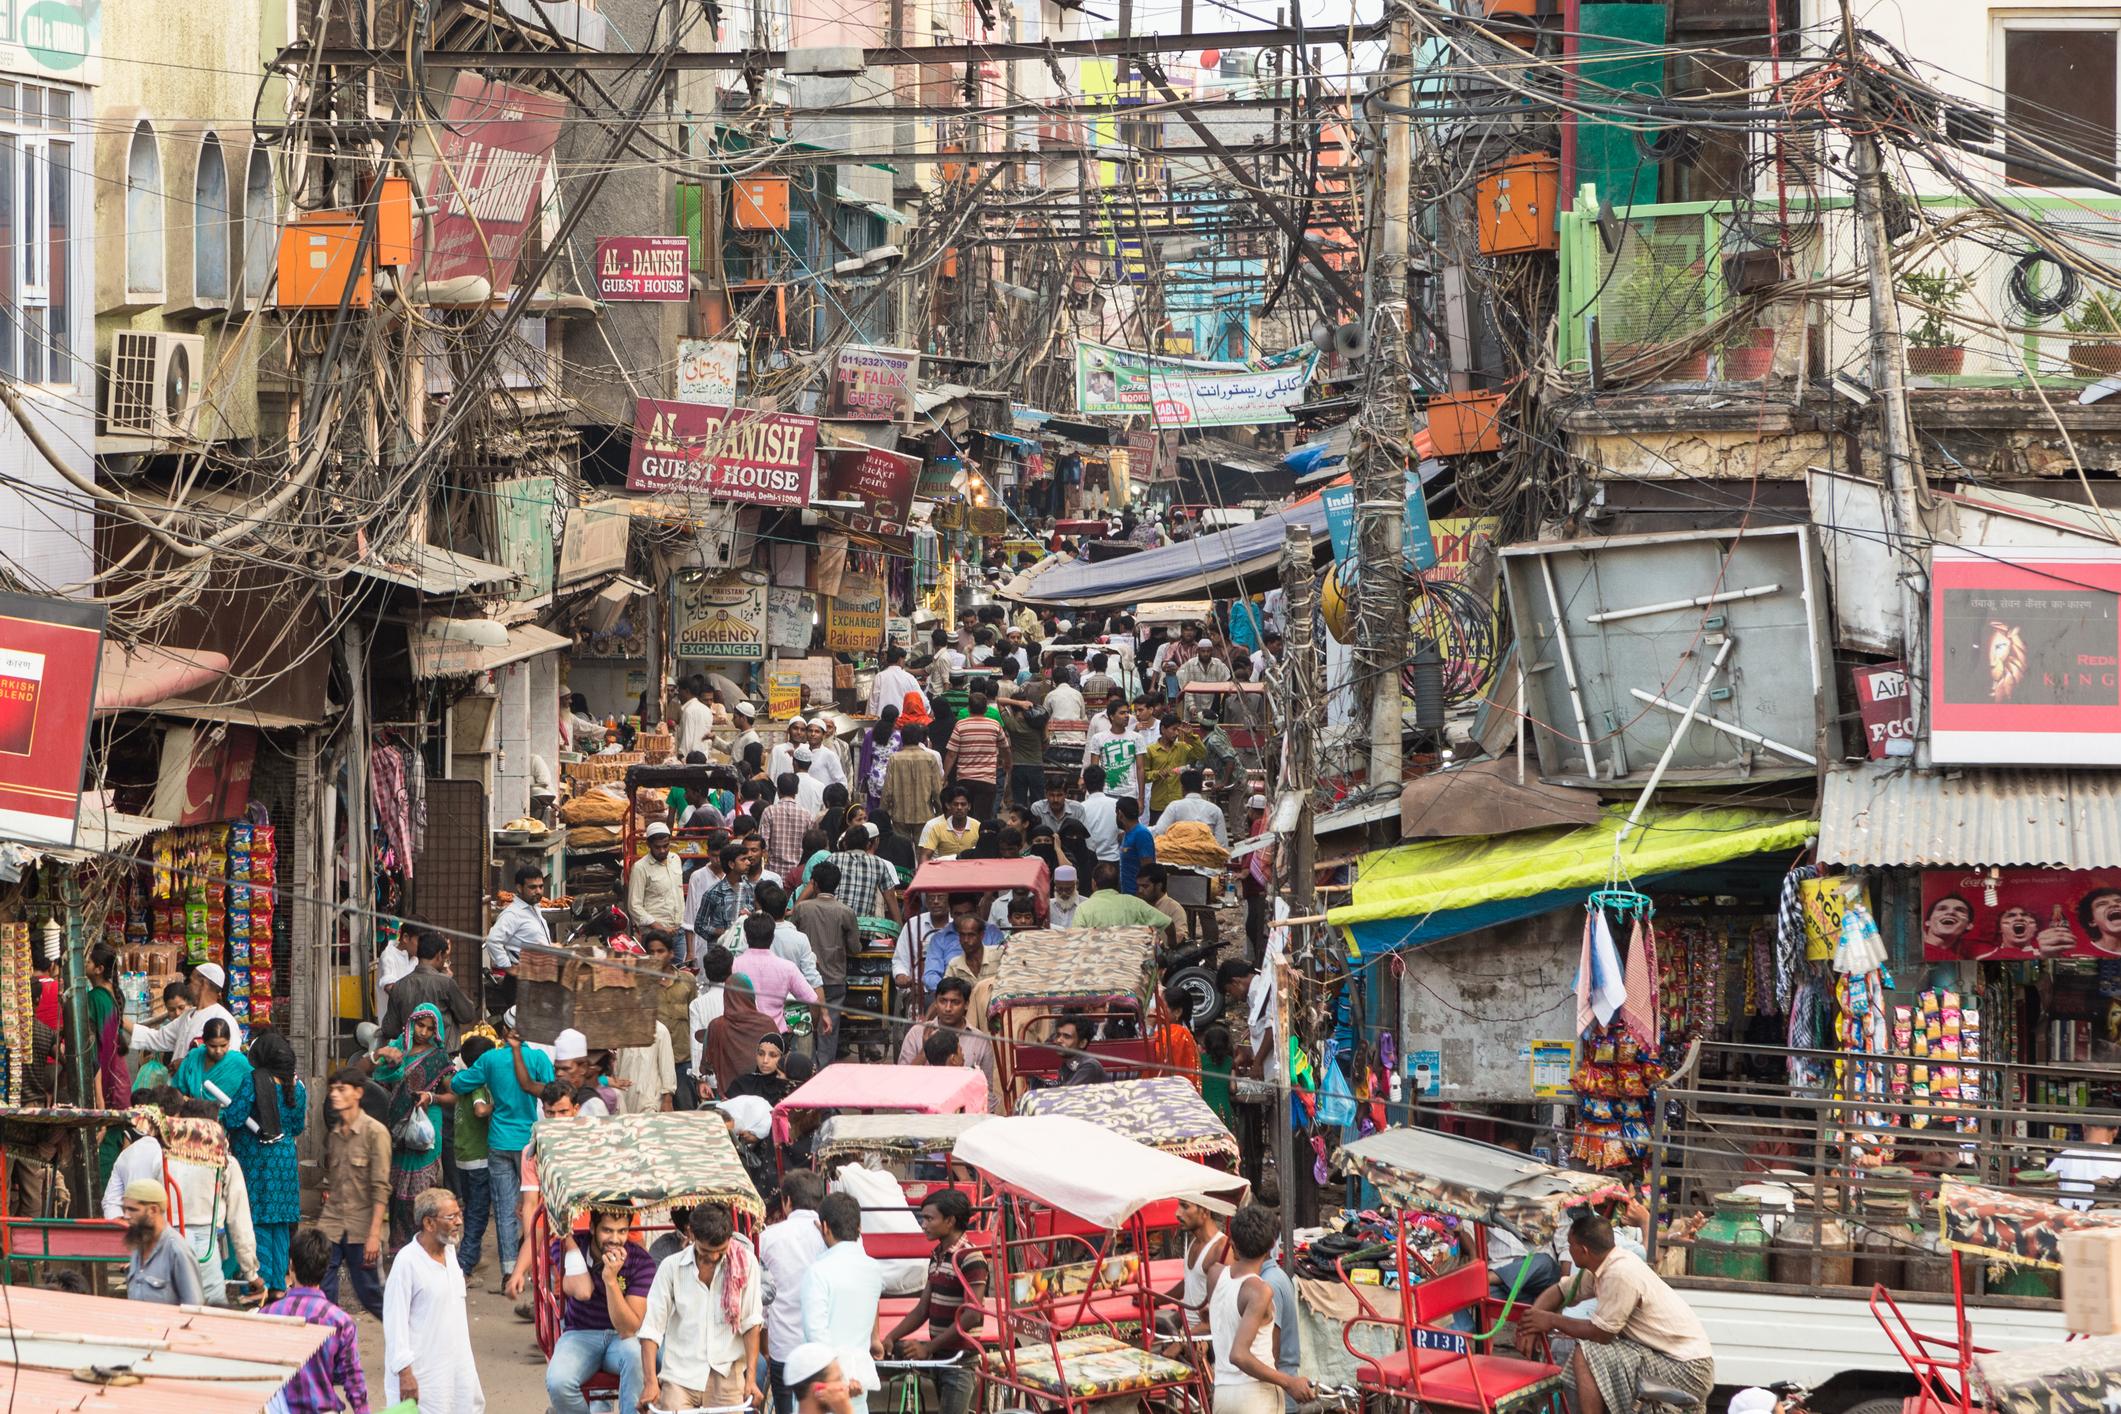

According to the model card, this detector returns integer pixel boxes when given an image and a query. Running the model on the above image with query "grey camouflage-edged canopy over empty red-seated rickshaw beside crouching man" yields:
[1334,1130,1627,1247]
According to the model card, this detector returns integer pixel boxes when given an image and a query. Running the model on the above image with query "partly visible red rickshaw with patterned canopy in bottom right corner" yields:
[1871,1181,2121,1414]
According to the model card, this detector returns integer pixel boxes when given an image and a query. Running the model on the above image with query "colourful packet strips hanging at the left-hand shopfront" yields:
[143,820,278,1024]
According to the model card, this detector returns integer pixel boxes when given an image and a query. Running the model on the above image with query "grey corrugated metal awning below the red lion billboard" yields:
[1820,761,2121,869]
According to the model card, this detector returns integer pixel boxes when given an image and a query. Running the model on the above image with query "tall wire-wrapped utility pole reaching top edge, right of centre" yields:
[1355,0,1415,793]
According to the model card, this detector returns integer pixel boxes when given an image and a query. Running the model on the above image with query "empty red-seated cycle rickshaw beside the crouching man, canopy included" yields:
[1334,1130,1623,1414]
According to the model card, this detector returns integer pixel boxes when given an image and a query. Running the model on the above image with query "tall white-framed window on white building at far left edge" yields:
[0,83,78,384]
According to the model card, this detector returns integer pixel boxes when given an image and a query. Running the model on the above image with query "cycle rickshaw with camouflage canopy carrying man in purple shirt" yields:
[530,1109,766,1373]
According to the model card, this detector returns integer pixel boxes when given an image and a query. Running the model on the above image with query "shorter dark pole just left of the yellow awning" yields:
[1260,528,1324,1253]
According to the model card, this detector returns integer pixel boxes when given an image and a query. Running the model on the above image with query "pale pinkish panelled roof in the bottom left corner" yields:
[0,1287,331,1414]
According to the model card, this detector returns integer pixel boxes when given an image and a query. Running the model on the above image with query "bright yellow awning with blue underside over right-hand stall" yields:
[1326,806,1820,954]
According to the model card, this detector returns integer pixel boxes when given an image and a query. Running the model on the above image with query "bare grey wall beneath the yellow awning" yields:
[1400,909,1584,1104]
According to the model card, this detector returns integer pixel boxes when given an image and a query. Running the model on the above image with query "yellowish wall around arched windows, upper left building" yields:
[93,0,284,439]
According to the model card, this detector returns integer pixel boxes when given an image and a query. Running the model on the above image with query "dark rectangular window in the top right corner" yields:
[1998,13,2121,187]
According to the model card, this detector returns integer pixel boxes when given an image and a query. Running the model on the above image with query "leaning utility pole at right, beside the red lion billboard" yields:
[1841,0,1930,765]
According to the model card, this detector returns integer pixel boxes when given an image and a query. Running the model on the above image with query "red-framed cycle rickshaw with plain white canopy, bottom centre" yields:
[952,1115,1247,1414]
